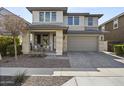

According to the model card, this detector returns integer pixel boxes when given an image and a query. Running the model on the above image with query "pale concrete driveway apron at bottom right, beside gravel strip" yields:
[63,77,124,86]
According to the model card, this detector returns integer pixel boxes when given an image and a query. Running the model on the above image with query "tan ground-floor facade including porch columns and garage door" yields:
[22,30,107,55]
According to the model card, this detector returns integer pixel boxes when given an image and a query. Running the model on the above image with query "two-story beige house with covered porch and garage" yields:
[23,7,107,55]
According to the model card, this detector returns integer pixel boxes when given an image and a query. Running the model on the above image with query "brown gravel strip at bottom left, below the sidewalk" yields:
[0,76,72,86]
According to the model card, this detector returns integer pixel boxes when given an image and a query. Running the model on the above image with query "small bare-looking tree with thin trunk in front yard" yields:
[2,15,28,60]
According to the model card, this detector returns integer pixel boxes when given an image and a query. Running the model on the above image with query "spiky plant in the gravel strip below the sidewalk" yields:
[14,72,26,86]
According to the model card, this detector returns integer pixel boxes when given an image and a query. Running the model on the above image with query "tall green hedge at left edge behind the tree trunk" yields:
[0,36,19,56]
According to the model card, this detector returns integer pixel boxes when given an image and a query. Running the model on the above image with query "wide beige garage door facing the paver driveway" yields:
[68,36,97,51]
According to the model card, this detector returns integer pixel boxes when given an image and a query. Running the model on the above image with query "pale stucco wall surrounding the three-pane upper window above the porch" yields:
[32,11,63,24]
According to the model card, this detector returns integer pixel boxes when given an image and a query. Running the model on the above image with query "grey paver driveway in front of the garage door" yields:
[68,52,124,69]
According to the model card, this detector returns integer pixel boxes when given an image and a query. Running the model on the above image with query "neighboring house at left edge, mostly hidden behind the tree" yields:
[0,7,30,43]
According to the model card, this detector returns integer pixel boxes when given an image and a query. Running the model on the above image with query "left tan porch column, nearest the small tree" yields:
[22,31,30,54]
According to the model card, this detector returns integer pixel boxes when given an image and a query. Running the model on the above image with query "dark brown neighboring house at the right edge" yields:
[99,13,124,43]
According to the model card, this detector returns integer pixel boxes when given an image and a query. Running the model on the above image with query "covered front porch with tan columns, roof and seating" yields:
[22,25,67,55]
